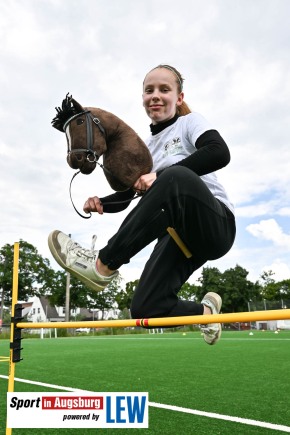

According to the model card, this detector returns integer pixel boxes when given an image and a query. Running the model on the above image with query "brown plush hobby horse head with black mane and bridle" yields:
[52,94,152,191]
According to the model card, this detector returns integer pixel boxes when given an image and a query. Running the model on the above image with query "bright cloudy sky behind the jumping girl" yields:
[0,0,290,282]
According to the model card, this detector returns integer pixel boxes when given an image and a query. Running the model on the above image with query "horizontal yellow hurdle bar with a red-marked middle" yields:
[16,309,290,329]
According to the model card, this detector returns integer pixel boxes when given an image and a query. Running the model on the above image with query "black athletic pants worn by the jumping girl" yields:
[99,166,236,318]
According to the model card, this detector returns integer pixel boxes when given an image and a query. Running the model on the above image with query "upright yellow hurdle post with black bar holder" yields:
[6,242,19,435]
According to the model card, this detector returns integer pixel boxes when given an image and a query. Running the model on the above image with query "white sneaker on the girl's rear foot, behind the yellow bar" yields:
[200,292,222,345]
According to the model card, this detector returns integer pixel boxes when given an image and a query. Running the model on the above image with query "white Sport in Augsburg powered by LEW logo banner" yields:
[7,391,149,429]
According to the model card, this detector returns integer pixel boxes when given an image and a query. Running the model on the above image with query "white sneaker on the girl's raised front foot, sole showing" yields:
[48,230,119,291]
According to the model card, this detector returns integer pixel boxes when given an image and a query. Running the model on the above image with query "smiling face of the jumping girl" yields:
[142,68,183,124]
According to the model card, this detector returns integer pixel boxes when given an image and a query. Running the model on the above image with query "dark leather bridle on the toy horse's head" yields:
[63,110,106,163]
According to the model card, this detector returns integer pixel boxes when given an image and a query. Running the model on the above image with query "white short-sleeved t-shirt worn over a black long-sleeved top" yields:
[145,112,234,213]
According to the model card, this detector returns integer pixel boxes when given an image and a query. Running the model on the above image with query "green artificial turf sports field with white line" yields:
[0,330,290,435]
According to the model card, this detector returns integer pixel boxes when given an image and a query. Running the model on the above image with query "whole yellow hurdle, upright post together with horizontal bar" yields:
[0,242,290,435]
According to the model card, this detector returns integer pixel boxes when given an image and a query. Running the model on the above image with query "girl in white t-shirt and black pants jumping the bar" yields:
[49,65,236,345]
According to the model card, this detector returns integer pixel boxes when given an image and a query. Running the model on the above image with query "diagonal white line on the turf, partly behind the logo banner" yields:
[0,375,290,433]
